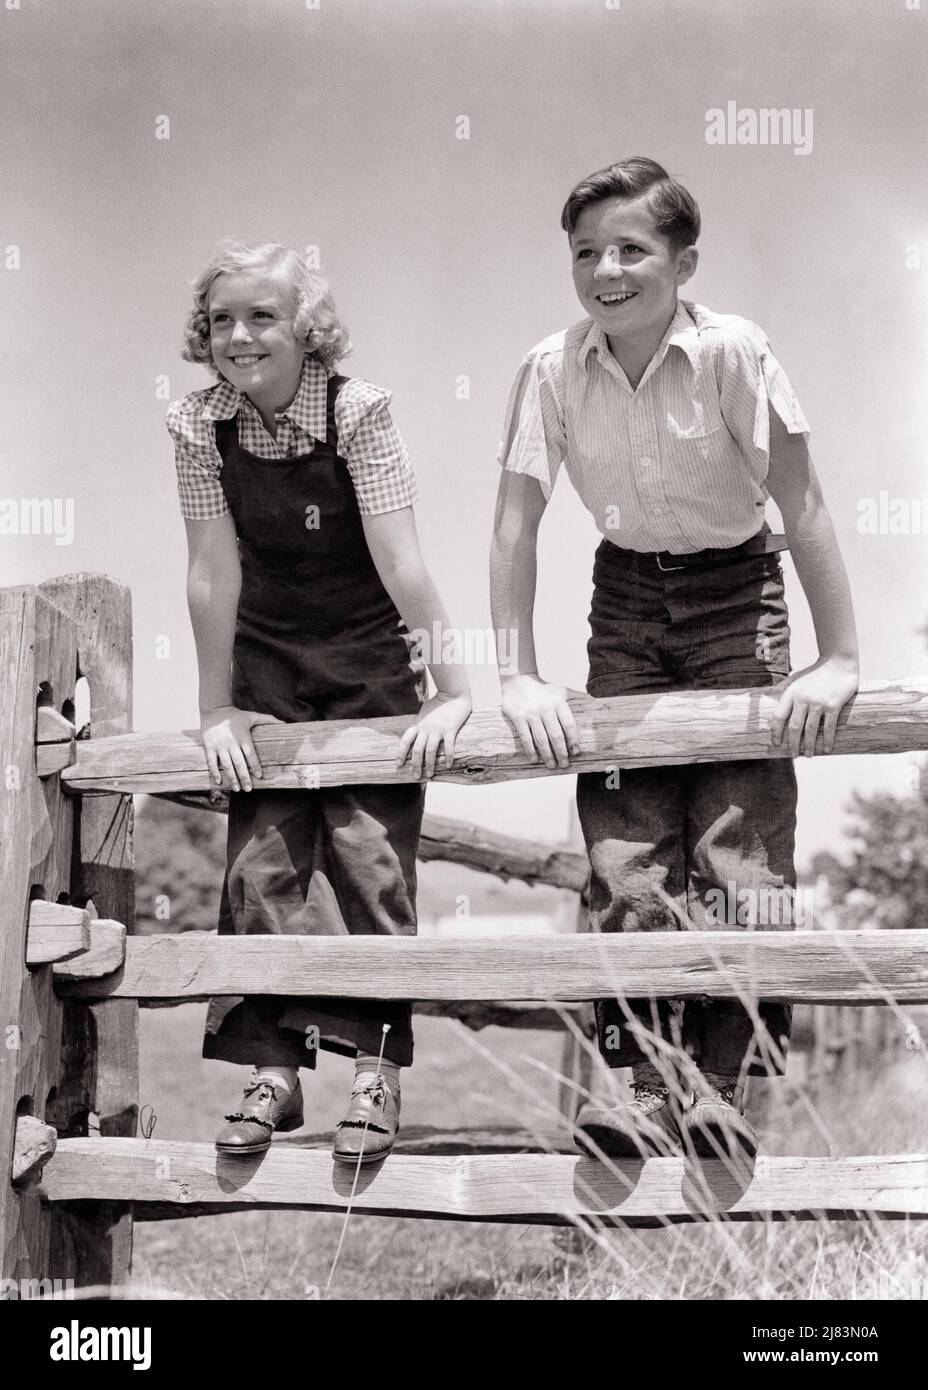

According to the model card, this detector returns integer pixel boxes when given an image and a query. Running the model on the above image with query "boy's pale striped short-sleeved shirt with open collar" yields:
[499,300,809,555]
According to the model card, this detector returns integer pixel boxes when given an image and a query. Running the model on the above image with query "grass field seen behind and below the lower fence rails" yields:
[132,1005,928,1300]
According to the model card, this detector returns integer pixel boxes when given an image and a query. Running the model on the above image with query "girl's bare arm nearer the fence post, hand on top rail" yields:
[185,514,279,791]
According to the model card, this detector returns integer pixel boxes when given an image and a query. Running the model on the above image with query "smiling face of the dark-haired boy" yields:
[570,196,699,358]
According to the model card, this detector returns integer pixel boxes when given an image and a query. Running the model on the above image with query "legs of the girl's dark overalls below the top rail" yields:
[203,785,425,1068]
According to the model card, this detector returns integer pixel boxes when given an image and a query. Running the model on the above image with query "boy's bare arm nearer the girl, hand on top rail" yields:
[490,468,579,767]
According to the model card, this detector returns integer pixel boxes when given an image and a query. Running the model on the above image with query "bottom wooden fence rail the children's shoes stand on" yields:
[42,1140,928,1226]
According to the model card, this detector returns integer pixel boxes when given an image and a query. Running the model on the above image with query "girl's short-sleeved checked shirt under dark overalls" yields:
[167,356,418,521]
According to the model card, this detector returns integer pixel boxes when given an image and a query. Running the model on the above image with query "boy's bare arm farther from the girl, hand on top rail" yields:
[767,406,860,758]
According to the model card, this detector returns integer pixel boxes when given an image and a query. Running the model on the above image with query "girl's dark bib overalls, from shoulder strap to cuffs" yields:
[203,377,424,1068]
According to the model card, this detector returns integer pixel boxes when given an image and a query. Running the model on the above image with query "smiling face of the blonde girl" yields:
[207,270,306,410]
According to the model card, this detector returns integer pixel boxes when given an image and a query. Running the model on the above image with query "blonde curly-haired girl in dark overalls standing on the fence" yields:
[167,242,471,1161]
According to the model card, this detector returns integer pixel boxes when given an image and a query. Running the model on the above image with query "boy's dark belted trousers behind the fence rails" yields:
[577,541,796,1076]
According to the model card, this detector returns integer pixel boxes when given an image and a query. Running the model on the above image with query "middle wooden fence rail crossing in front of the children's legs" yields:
[54,931,928,1004]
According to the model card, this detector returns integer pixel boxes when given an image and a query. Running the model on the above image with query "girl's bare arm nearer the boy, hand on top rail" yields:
[361,507,472,777]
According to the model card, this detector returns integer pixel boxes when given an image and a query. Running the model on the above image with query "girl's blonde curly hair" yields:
[181,242,351,377]
